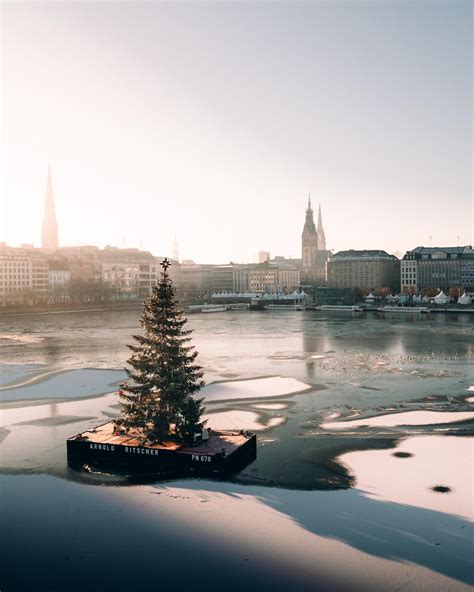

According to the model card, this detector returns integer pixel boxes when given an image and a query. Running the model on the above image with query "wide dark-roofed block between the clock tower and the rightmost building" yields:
[327,249,400,292]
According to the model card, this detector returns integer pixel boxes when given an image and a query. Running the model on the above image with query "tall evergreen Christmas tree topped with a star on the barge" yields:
[118,259,205,441]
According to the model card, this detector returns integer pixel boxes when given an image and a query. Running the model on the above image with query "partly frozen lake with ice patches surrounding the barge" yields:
[0,310,474,591]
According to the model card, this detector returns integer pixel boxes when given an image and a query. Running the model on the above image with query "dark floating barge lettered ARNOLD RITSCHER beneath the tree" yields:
[67,421,257,474]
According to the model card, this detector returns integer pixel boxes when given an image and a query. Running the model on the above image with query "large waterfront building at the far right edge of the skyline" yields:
[400,245,474,293]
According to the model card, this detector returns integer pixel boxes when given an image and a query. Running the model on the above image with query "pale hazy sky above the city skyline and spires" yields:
[0,0,473,262]
